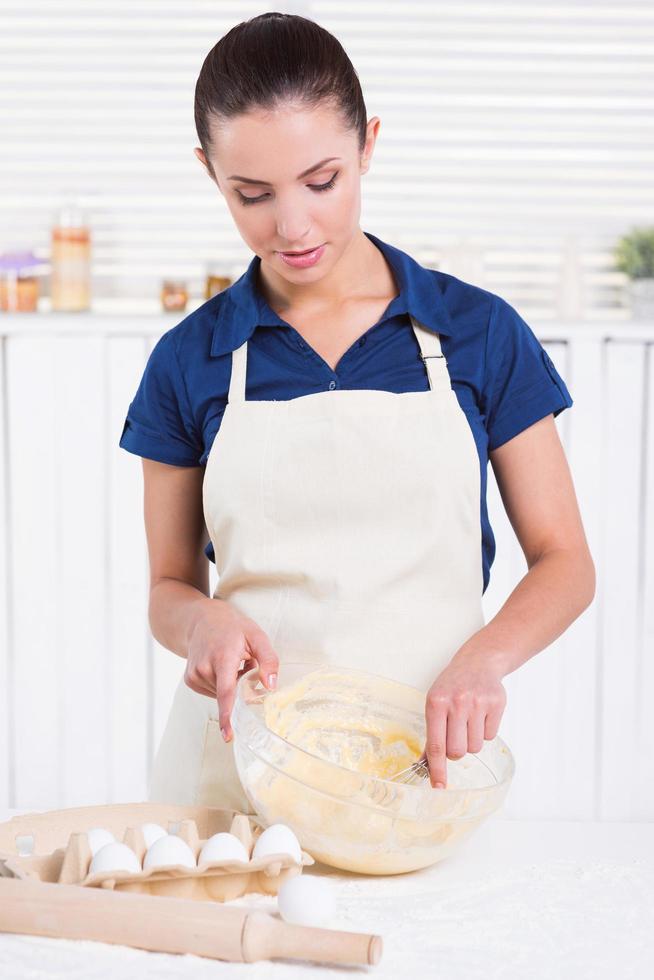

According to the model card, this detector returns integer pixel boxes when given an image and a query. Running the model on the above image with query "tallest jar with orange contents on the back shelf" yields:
[50,205,91,312]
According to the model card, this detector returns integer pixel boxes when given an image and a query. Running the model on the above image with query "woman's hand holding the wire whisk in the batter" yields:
[425,649,506,789]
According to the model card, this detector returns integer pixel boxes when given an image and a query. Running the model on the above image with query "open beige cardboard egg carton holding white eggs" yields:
[0,804,314,902]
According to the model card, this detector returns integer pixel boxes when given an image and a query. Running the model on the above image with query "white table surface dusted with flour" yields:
[0,810,654,980]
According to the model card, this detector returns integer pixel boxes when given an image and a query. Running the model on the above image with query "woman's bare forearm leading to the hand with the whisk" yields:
[454,549,595,677]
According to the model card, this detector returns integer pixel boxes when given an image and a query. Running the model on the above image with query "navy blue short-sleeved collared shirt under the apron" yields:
[119,232,572,592]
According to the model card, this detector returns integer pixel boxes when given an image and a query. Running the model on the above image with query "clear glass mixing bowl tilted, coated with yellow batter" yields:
[232,663,515,874]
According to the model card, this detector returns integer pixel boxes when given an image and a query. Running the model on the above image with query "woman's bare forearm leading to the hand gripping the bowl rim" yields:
[148,578,220,658]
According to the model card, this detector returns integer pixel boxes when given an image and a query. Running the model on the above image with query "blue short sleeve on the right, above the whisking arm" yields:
[484,296,573,450]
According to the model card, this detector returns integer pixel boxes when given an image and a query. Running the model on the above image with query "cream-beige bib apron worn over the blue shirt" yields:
[149,317,484,812]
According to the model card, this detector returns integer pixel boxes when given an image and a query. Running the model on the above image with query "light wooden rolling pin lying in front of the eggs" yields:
[0,878,382,964]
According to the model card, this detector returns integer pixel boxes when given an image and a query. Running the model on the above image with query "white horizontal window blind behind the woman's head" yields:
[0,0,654,321]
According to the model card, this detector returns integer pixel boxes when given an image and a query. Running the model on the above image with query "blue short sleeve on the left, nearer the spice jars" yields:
[119,330,204,466]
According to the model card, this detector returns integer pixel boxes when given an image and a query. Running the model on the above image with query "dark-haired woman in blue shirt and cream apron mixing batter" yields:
[120,13,595,812]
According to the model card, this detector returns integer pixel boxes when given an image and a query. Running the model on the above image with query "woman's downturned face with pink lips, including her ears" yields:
[195,105,380,284]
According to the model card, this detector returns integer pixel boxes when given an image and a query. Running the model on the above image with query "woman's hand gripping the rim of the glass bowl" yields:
[184,597,279,742]
